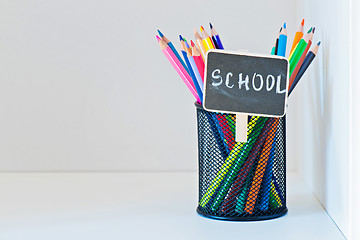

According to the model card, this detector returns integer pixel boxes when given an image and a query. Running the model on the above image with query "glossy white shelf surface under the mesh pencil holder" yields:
[0,172,345,240]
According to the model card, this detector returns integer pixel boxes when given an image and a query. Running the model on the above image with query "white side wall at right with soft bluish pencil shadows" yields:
[294,0,351,237]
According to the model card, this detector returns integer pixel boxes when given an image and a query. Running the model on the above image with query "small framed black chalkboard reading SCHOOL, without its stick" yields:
[203,50,289,117]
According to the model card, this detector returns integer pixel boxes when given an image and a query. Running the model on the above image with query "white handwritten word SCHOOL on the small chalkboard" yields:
[211,69,286,94]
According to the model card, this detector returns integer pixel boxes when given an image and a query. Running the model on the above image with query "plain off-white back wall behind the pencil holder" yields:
[0,0,299,171]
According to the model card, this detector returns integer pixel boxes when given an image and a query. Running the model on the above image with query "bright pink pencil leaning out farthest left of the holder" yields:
[156,36,201,103]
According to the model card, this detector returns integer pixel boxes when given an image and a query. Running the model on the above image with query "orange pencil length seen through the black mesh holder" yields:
[245,118,279,214]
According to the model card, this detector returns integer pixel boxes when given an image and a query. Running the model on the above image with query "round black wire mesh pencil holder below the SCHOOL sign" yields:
[195,103,287,221]
